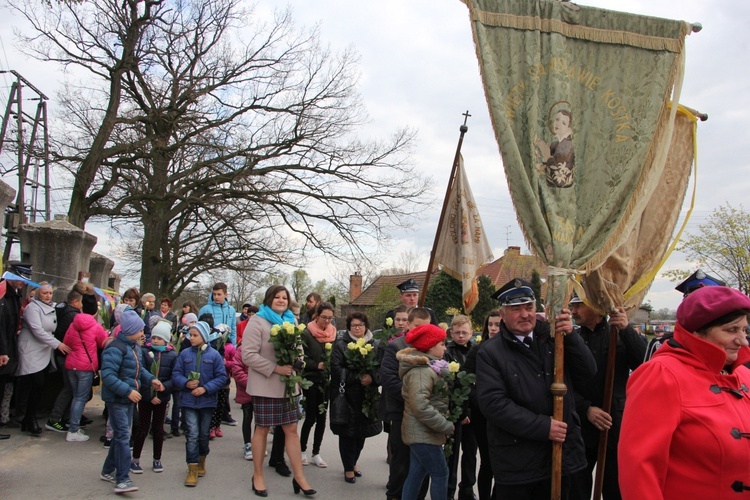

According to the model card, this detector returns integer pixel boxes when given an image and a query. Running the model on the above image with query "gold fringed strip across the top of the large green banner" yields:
[467,9,690,53]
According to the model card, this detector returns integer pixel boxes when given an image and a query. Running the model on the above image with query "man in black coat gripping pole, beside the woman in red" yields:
[569,294,646,500]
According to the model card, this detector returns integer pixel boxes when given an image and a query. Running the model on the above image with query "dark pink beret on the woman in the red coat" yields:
[677,286,750,332]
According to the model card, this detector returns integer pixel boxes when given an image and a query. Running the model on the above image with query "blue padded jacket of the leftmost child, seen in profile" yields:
[102,335,154,403]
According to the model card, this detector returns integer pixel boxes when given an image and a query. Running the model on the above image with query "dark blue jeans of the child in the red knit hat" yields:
[401,443,448,500]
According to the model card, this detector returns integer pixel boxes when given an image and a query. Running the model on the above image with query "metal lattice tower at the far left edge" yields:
[0,70,50,262]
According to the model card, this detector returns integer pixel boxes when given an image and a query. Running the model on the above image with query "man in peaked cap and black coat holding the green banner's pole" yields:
[476,279,596,500]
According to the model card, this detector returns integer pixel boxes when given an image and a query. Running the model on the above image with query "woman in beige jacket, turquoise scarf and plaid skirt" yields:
[242,285,316,497]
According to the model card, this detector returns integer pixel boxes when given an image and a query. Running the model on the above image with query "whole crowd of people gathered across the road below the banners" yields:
[0,268,750,500]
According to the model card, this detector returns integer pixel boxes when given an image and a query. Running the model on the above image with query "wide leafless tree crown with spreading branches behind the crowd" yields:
[13,0,427,295]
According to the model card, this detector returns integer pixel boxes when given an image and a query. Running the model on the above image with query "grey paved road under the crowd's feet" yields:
[0,386,396,500]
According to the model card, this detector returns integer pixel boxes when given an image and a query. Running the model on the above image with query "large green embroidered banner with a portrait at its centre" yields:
[464,0,690,310]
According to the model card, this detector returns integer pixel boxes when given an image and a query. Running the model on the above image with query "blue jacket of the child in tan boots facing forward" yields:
[172,346,228,409]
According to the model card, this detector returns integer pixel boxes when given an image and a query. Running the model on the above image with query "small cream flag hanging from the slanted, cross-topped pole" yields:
[435,155,492,314]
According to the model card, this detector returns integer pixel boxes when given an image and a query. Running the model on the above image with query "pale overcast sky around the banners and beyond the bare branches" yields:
[0,0,750,309]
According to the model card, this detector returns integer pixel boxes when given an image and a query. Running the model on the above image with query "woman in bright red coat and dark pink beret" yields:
[618,287,750,500]
